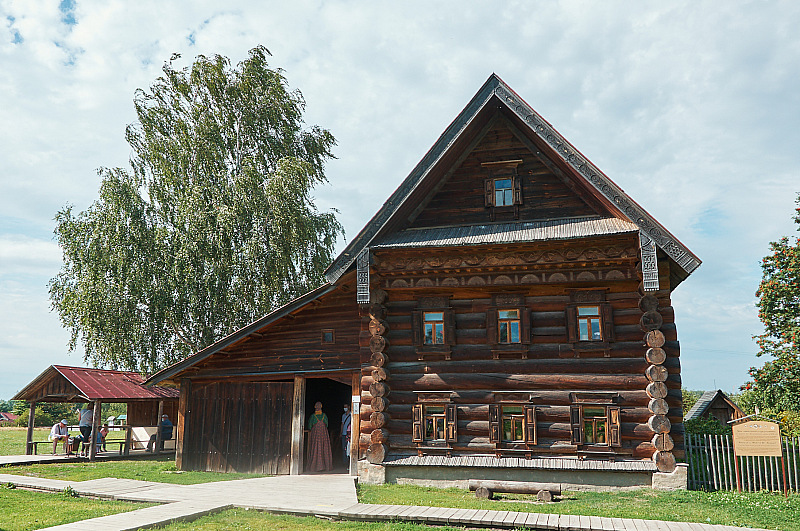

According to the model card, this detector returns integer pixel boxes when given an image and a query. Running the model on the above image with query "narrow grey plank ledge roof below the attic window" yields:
[371,217,639,249]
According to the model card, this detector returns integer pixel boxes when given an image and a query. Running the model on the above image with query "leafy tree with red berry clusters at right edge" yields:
[743,194,800,411]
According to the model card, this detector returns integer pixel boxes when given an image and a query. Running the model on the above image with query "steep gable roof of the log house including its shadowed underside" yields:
[325,74,701,285]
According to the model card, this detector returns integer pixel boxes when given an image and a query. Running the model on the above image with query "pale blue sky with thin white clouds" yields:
[0,0,800,399]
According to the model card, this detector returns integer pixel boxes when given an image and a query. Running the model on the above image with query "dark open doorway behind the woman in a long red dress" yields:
[303,376,353,472]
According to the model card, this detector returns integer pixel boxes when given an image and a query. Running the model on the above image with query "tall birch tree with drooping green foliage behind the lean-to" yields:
[50,47,343,372]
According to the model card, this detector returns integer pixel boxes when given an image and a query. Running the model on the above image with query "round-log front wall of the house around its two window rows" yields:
[360,251,683,458]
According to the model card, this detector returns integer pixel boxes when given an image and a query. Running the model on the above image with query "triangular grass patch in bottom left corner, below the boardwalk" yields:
[0,486,151,531]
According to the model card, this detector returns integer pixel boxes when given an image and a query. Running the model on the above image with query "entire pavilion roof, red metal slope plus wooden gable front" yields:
[12,365,179,402]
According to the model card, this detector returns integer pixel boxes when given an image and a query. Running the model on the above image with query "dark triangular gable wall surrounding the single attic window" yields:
[411,122,597,228]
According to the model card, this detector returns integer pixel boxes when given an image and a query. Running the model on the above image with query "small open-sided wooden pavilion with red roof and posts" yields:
[13,365,179,460]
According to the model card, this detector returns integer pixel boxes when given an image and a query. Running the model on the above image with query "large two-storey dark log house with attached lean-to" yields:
[149,75,700,490]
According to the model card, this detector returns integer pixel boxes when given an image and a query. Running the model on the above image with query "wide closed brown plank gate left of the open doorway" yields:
[182,382,294,474]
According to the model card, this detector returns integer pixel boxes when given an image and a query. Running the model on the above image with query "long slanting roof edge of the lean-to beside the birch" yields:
[144,284,337,385]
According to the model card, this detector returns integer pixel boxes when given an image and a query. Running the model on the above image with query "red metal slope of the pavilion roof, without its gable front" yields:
[53,365,179,401]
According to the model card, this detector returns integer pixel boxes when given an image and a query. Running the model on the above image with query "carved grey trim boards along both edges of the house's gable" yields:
[325,74,701,283]
